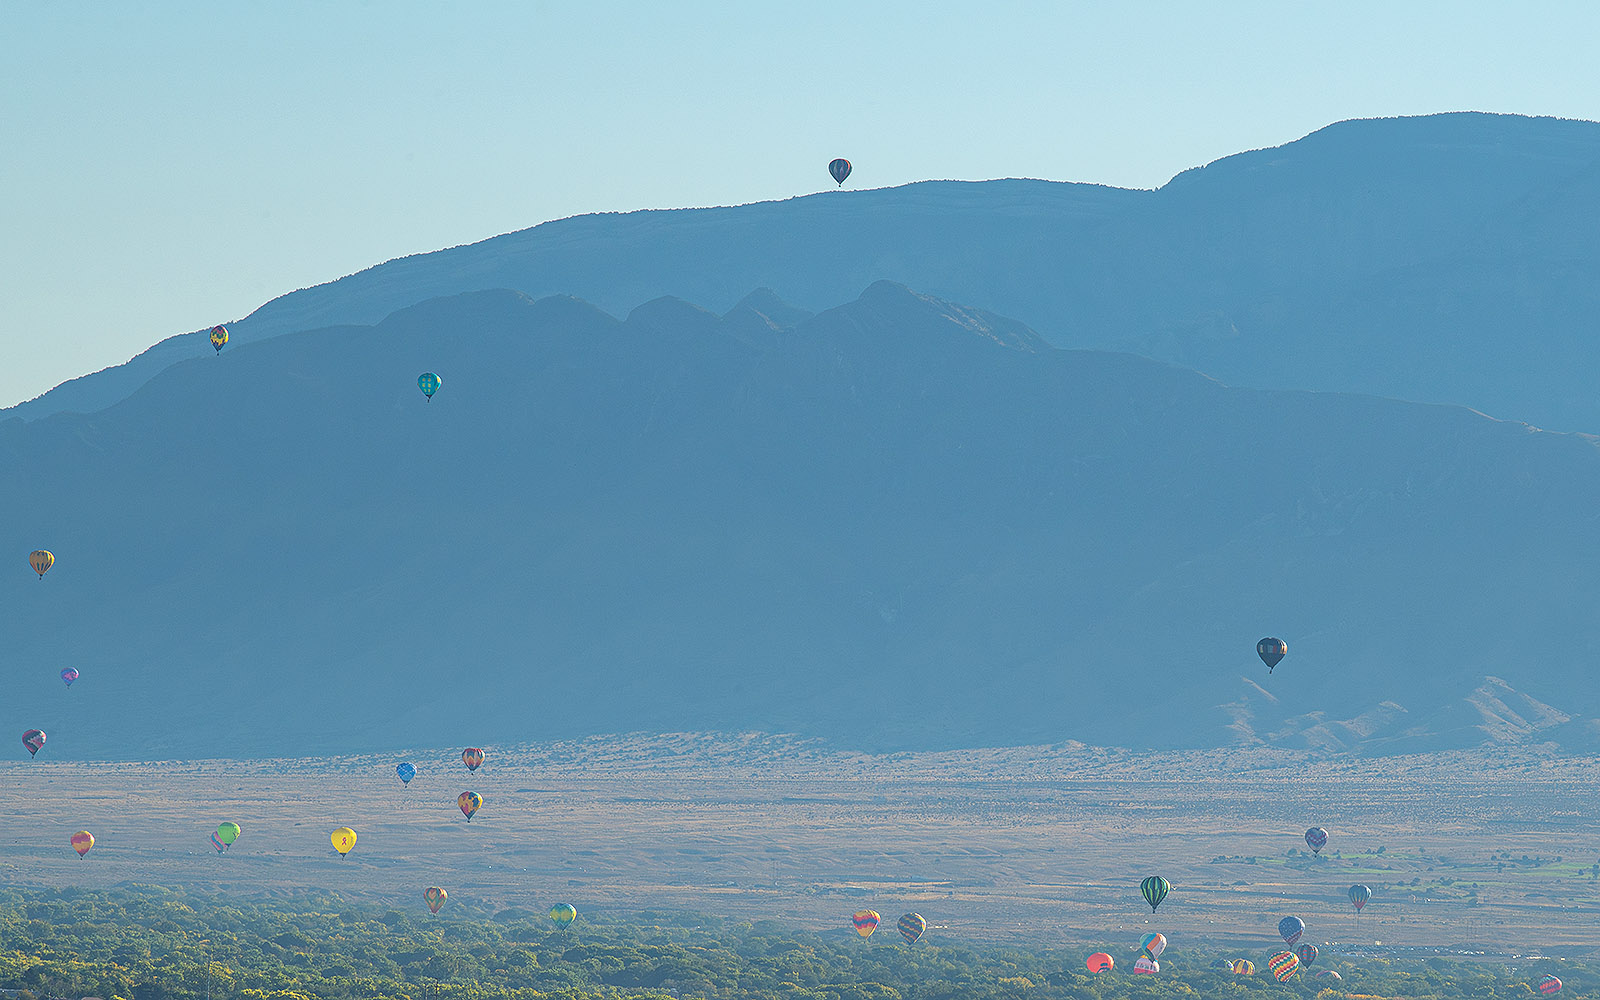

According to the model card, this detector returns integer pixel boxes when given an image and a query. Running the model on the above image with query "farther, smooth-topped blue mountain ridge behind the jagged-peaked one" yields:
[14,114,1600,430]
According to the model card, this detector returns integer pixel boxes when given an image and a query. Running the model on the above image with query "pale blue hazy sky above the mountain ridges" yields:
[0,0,1600,405]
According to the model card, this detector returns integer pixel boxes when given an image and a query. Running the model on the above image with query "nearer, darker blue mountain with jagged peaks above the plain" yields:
[9,283,1600,757]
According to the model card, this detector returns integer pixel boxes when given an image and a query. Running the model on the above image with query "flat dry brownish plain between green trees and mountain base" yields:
[0,736,1600,957]
